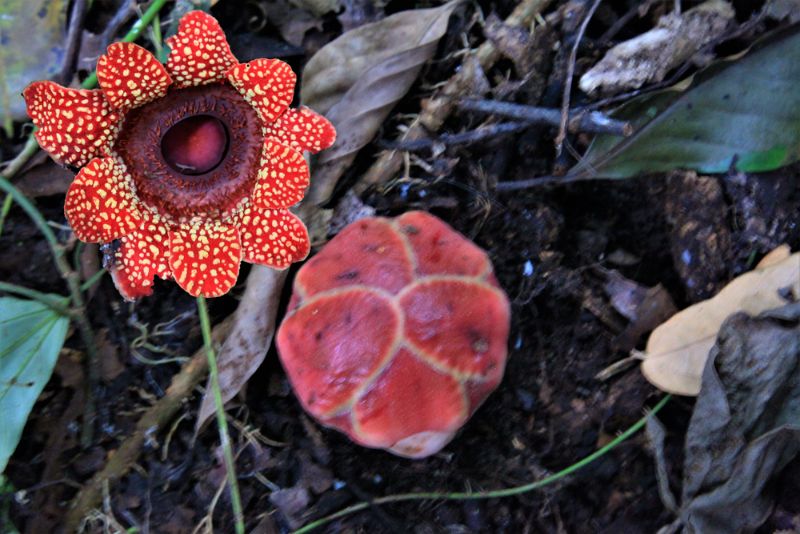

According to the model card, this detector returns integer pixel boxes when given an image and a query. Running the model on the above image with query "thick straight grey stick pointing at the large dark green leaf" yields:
[458,99,633,136]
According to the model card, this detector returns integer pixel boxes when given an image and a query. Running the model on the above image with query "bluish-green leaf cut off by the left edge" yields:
[0,297,69,473]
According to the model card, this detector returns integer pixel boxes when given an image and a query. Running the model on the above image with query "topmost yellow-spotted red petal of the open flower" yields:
[167,11,237,87]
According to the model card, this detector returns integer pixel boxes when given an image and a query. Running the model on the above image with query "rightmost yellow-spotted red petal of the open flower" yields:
[266,106,336,154]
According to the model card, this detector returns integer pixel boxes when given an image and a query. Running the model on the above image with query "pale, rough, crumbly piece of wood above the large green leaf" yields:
[580,0,736,93]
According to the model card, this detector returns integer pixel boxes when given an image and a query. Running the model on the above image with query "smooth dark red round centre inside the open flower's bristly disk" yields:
[161,115,228,176]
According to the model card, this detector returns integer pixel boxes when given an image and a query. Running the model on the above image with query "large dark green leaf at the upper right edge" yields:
[569,29,800,178]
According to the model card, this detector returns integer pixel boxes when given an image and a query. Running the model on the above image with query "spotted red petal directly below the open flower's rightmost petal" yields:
[253,139,309,209]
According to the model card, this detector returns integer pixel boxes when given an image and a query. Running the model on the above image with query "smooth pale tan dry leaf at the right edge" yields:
[641,249,800,395]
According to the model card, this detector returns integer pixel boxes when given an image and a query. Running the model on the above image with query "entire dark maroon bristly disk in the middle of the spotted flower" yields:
[115,83,264,221]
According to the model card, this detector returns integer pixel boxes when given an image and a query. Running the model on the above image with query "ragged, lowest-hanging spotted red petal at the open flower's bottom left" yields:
[109,209,172,300]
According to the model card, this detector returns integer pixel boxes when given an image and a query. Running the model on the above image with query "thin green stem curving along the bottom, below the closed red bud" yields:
[293,395,672,534]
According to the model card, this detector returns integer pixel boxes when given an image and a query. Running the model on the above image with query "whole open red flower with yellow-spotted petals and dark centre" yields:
[24,11,336,299]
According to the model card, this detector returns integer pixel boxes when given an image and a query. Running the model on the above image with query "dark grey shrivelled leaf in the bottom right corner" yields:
[648,303,800,534]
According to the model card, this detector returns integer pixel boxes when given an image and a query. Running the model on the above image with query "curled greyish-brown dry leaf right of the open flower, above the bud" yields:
[300,0,461,205]
